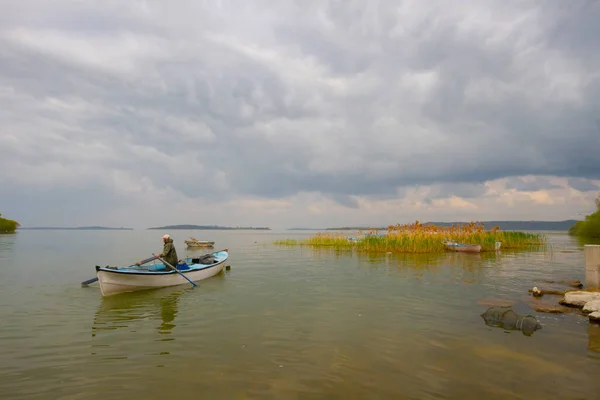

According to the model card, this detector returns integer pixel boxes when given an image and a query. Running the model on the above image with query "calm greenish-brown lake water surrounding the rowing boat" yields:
[0,230,600,399]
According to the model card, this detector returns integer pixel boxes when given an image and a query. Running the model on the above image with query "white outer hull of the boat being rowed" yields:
[97,253,228,296]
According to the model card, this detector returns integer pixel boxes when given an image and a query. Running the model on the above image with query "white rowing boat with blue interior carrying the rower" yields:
[96,249,229,296]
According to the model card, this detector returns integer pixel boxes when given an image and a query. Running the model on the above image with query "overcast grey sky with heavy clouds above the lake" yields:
[0,0,600,229]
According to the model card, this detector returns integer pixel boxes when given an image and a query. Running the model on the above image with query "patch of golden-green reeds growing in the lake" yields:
[274,221,547,253]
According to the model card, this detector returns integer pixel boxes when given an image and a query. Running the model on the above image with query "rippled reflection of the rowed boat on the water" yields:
[92,287,189,337]
